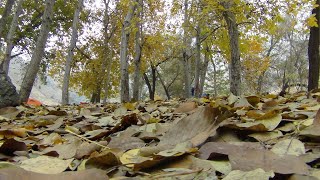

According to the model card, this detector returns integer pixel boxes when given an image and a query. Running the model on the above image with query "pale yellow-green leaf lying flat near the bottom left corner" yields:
[20,156,72,174]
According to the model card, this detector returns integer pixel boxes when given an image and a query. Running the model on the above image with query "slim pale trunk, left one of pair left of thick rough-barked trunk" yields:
[182,0,191,98]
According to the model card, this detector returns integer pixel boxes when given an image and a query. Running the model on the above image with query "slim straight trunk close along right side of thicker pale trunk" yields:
[132,0,143,101]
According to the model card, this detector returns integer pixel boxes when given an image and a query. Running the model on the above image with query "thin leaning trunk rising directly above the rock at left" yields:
[1,0,24,74]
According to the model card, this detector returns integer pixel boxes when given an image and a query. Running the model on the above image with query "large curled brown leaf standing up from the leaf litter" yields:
[141,107,229,156]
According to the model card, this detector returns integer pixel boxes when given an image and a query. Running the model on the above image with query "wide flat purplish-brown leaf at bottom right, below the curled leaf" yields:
[199,142,309,174]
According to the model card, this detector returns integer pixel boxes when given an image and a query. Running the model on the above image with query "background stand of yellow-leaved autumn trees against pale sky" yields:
[0,0,319,104]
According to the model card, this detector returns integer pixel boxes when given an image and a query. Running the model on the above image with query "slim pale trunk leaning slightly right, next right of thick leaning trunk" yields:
[62,0,83,104]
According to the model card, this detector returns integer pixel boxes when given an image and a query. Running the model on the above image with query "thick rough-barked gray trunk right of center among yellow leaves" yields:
[223,2,241,96]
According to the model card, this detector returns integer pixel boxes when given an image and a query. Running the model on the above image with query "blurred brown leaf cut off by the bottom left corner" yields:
[0,168,109,180]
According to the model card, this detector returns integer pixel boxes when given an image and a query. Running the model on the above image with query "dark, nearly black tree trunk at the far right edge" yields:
[308,0,320,91]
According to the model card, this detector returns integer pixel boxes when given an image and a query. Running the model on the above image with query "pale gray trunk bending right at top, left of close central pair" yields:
[120,1,137,102]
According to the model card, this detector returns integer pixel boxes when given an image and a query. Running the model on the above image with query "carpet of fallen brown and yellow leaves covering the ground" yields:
[0,91,320,180]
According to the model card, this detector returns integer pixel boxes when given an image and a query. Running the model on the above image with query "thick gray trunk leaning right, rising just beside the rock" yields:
[20,0,55,102]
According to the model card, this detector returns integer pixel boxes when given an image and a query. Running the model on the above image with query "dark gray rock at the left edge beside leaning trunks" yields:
[0,70,19,108]
